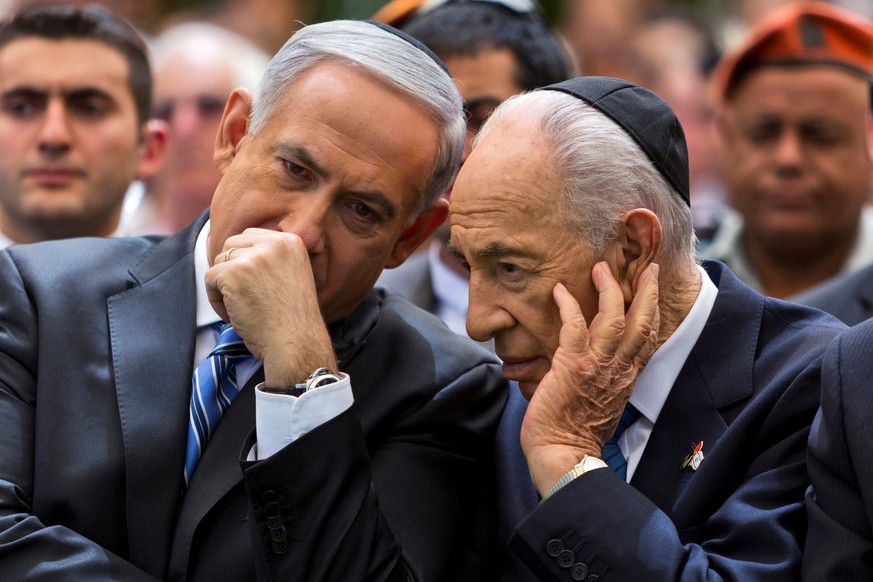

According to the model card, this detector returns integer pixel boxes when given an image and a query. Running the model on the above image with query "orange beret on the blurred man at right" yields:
[712,2,873,102]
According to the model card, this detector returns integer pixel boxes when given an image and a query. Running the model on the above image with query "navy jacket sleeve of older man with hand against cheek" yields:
[510,358,820,581]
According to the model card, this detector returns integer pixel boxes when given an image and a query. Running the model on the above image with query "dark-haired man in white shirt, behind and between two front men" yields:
[377,0,571,342]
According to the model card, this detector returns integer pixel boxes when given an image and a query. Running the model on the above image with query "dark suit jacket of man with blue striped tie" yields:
[0,219,505,581]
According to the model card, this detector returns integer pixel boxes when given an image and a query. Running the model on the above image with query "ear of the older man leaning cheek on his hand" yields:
[604,208,663,305]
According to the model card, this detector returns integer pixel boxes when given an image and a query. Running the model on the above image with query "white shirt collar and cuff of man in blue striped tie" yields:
[192,221,354,460]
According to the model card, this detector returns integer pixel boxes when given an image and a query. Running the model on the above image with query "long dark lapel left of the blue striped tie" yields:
[107,220,202,572]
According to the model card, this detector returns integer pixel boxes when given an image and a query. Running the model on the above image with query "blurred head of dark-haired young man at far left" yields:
[0,37,155,242]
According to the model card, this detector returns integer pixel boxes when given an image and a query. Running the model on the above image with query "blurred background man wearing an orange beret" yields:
[704,2,873,298]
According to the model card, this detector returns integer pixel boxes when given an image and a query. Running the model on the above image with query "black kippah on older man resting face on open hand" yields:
[537,76,691,206]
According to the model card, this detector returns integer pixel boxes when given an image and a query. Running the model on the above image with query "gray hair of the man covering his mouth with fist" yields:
[249,20,466,220]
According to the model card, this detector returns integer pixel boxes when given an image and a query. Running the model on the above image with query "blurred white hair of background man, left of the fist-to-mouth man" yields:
[150,22,270,91]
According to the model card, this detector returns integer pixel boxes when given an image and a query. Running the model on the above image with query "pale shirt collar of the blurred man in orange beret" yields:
[701,206,873,293]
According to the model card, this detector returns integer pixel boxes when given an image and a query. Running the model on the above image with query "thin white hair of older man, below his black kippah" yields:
[477,91,698,272]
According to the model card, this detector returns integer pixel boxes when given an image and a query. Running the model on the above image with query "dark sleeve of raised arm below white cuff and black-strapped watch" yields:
[244,354,506,581]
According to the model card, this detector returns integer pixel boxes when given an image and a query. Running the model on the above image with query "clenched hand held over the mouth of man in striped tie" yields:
[206,228,336,388]
